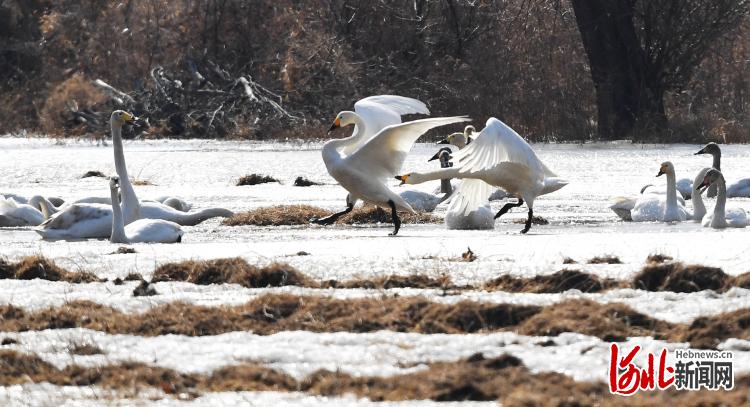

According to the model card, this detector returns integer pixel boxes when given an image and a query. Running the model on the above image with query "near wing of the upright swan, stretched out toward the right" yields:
[345,116,471,179]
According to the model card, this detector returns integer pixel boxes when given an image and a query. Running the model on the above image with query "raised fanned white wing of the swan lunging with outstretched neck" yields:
[453,117,556,180]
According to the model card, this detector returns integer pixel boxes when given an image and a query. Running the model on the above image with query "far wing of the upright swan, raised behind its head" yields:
[341,95,430,155]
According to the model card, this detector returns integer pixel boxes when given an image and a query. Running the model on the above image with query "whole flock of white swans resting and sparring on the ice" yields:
[0,95,750,243]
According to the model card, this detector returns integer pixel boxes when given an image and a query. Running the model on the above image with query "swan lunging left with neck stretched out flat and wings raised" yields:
[396,117,568,233]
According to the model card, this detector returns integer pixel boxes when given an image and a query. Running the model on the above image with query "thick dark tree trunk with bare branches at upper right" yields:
[571,0,750,139]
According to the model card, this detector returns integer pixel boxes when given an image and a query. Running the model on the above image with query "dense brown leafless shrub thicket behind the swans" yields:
[0,0,750,142]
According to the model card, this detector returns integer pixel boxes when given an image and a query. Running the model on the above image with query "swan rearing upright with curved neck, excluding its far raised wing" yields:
[311,99,469,236]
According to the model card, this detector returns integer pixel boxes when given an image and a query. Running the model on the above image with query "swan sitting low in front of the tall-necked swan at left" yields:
[109,177,183,243]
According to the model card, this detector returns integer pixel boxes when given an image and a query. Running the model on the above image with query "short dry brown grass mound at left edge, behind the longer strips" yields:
[0,256,106,283]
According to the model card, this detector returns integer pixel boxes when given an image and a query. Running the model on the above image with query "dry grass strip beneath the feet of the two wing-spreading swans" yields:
[222,205,443,226]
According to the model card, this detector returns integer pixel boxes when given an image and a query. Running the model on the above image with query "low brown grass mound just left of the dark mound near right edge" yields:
[483,269,618,293]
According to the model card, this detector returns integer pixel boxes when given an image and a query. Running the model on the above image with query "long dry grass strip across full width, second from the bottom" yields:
[0,294,750,348]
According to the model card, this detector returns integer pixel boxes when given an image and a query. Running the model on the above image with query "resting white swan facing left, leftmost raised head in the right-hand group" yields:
[631,161,690,222]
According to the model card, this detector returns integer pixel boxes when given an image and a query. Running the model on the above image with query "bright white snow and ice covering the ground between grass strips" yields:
[0,138,750,405]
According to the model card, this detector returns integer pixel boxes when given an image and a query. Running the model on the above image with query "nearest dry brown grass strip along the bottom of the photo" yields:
[0,351,750,406]
